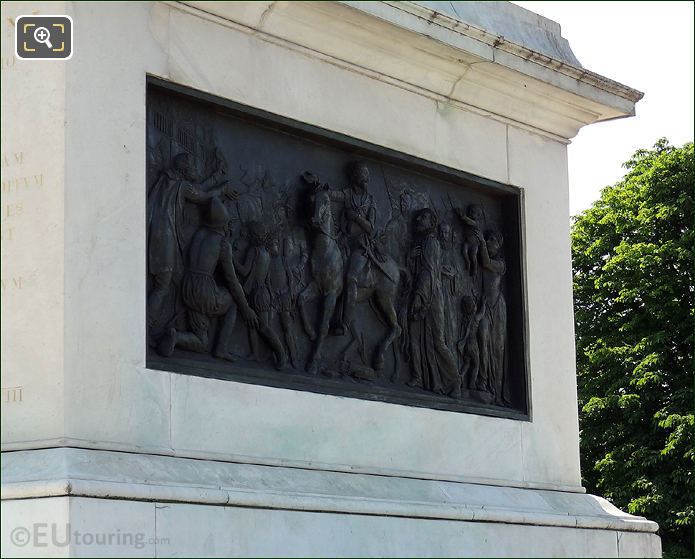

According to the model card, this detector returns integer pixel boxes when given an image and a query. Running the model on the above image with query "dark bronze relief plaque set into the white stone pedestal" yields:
[146,79,528,419]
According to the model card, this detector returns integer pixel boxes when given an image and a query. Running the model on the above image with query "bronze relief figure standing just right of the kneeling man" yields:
[237,221,287,368]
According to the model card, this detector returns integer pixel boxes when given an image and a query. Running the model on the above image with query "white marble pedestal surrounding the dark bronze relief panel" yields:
[2,1,660,557]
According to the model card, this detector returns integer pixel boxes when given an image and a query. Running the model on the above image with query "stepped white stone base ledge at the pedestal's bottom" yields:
[2,448,661,557]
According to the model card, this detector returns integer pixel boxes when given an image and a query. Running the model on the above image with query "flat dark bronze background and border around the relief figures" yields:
[146,77,530,419]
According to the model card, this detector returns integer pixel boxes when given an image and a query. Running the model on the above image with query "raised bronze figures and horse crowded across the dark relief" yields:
[147,150,509,406]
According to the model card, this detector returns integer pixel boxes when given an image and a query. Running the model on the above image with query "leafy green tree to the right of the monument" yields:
[572,139,695,557]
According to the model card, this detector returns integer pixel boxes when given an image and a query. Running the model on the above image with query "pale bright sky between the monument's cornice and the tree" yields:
[514,1,695,215]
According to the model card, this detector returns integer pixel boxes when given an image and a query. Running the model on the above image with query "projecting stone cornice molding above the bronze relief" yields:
[177,0,643,142]
